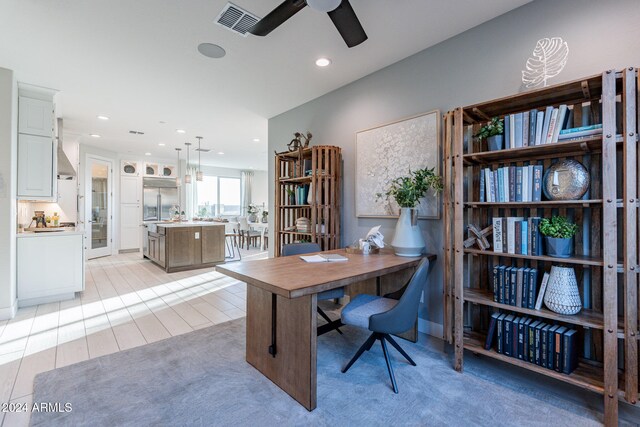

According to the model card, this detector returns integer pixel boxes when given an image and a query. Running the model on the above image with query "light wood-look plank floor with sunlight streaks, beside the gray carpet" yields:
[0,249,267,427]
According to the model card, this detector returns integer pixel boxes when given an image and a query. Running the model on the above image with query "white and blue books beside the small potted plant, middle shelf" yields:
[491,216,542,255]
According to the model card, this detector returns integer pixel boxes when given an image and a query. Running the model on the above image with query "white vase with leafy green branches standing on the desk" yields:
[378,168,443,256]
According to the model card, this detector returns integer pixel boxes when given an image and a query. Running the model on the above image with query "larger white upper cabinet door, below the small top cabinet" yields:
[18,133,57,200]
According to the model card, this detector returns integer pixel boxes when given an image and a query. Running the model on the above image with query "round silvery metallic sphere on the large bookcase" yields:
[542,159,590,200]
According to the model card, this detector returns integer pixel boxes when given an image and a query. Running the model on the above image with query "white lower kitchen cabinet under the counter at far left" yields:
[17,231,84,307]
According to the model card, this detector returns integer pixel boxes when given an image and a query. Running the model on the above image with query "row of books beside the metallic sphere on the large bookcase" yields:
[480,165,542,203]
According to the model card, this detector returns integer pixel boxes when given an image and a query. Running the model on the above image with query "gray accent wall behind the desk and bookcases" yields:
[268,0,640,335]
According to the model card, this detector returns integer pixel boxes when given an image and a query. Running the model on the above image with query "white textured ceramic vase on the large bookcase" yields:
[544,265,582,314]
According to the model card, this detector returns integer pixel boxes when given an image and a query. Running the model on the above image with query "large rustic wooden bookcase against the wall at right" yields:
[444,68,640,426]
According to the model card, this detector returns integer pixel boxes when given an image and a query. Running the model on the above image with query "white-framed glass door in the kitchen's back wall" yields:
[85,156,113,259]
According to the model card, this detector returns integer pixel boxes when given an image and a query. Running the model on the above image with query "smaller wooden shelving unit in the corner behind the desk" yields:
[274,145,342,256]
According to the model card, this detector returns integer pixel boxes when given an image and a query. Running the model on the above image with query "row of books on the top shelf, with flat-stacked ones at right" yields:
[504,104,602,149]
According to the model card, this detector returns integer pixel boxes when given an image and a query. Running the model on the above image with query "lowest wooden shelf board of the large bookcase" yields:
[464,334,604,394]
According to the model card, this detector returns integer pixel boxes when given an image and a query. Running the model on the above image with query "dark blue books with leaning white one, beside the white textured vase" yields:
[491,265,549,310]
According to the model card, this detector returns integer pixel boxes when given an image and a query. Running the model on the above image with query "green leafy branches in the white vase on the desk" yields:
[377,168,444,208]
